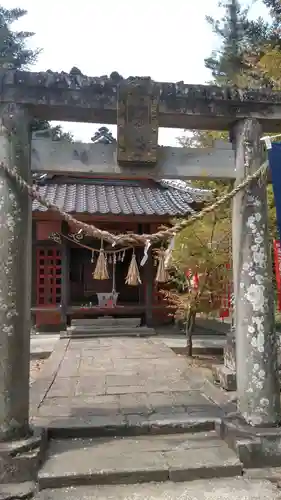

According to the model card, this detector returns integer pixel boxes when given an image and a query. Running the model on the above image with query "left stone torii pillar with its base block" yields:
[0,104,42,489]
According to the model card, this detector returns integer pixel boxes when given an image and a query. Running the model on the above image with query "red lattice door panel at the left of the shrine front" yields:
[36,248,62,307]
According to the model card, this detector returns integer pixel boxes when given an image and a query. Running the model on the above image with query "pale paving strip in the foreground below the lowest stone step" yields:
[35,478,281,500]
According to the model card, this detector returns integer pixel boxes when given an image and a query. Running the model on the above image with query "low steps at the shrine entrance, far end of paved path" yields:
[61,316,155,338]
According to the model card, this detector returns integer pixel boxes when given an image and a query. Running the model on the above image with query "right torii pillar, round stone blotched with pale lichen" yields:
[233,119,280,426]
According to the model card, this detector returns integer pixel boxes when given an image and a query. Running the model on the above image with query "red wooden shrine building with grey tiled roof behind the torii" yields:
[32,132,209,331]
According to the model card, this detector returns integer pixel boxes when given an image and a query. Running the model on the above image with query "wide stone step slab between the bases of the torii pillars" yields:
[38,431,242,489]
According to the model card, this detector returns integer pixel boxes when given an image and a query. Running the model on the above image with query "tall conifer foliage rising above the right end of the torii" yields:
[202,0,280,88]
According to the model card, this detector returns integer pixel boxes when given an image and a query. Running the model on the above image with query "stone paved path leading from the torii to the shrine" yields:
[31,338,222,426]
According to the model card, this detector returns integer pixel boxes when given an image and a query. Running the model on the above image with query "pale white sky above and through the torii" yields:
[6,0,266,145]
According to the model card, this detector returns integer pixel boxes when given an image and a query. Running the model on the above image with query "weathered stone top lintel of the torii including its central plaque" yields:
[0,68,281,166]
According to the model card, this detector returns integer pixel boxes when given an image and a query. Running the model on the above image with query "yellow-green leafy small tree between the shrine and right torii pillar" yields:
[166,213,231,322]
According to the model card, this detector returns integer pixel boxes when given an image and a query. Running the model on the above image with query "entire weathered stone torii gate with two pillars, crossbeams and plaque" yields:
[0,70,281,476]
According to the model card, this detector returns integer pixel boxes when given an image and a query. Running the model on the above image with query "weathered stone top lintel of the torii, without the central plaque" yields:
[0,69,281,132]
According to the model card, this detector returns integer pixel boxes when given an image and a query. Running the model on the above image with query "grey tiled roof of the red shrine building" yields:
[32,177,212,217]
